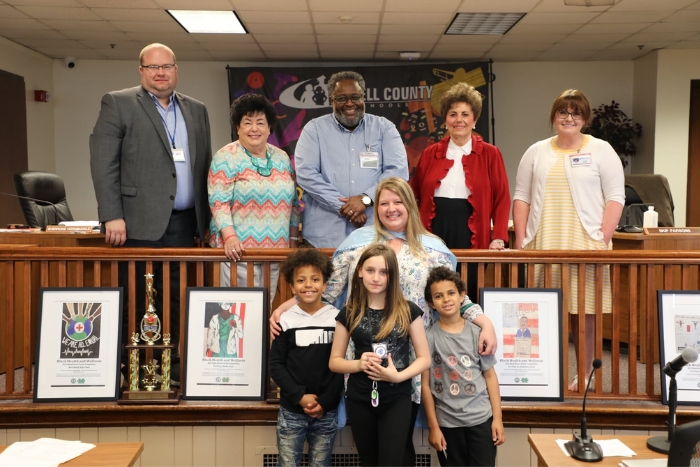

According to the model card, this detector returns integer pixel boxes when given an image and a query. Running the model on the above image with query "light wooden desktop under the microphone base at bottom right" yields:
[527,433,667,467]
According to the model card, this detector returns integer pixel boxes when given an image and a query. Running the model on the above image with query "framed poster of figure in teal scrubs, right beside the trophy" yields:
[182,287,268,400]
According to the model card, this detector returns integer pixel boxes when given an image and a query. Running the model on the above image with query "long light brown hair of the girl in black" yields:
[345,243,411,340]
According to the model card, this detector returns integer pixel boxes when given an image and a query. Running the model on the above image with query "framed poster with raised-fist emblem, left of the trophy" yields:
[34,287,122,402]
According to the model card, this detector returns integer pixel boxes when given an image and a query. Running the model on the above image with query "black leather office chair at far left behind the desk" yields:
[14,170,73,228]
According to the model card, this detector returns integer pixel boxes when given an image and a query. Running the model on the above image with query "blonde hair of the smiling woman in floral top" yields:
[374,177,439,258]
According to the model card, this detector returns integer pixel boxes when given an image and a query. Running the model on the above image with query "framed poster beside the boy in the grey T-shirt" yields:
[481,288,564,401]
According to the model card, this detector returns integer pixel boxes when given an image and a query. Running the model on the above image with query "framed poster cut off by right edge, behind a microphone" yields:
[657,290,700,405]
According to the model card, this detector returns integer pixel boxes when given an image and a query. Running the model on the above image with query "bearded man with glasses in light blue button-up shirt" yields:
[294,71,408,248]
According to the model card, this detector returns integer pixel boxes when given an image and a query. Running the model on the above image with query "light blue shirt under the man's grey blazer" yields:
[148,92,194,211]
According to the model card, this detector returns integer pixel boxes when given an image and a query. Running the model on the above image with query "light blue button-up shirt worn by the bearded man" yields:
[294,114,408,248]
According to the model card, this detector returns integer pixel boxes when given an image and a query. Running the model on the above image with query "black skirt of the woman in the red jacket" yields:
[430,197,474,249]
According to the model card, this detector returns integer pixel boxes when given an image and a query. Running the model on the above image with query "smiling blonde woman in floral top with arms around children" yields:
[270,177,496,465]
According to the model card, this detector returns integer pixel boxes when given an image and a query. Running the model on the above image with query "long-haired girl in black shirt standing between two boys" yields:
[329,244,430,466]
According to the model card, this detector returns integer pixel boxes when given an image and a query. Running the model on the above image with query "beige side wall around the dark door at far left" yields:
[0,37,56,172]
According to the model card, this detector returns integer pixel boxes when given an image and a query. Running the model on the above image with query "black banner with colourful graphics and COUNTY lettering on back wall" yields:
[228,62,490,170]
